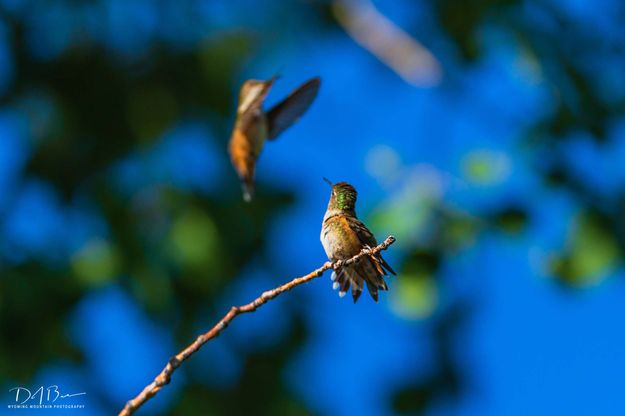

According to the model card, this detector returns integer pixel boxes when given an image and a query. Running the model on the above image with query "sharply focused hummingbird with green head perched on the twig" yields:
[321,178,395,303]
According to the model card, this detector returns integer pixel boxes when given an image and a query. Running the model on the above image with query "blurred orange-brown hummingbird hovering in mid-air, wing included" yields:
[228,76,321,202]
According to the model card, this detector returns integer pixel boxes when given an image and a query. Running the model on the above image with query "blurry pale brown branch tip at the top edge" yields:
[332,0,442,87]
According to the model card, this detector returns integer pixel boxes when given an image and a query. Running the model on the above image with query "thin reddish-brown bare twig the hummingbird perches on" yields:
[119,236,395,416]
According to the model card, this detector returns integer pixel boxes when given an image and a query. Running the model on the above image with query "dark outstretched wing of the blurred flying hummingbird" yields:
[267,77,321,140]
